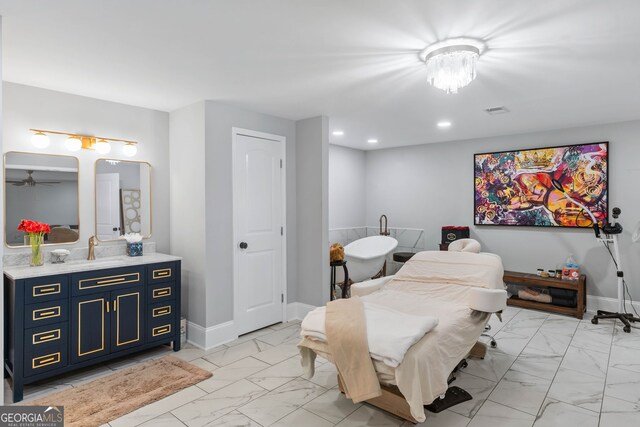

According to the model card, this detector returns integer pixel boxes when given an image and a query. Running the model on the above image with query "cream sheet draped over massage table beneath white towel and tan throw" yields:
[300,252,504,421]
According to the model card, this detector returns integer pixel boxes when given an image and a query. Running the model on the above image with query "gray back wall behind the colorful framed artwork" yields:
[366,121,640,300]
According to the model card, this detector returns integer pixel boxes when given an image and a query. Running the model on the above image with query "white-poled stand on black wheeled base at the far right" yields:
[591,208,640,333]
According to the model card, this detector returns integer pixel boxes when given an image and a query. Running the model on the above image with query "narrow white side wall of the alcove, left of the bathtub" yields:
[329,145,366,229]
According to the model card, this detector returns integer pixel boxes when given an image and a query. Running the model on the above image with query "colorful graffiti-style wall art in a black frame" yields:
[474,142,609,227]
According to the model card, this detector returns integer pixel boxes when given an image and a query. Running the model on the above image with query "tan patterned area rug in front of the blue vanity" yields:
[31,356,212,427]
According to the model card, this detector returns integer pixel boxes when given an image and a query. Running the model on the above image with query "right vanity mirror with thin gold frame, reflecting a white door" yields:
[96,159,151,241]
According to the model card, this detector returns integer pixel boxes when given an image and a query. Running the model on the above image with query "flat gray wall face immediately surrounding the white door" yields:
[204,101,297,326]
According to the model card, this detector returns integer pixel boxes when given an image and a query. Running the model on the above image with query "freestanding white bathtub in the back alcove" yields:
[337,236,398,283]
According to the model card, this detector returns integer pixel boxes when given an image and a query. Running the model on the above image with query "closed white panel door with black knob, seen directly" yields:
[233,134,284,334]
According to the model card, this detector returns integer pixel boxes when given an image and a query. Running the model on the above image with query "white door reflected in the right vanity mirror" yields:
[96,173,120,240]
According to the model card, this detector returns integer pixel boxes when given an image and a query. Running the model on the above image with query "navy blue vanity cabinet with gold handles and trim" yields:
[4,256,181,402]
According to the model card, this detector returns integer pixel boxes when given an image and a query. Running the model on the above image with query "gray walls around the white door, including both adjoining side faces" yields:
[170,101,329,334]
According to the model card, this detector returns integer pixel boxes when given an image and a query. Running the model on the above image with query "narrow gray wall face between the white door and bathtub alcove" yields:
[296,116,329,306]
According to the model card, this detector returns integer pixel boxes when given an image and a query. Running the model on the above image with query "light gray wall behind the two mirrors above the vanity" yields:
[2,82,169,252]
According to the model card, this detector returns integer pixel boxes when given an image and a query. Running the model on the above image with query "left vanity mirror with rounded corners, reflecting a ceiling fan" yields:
[4,152,80,247]
